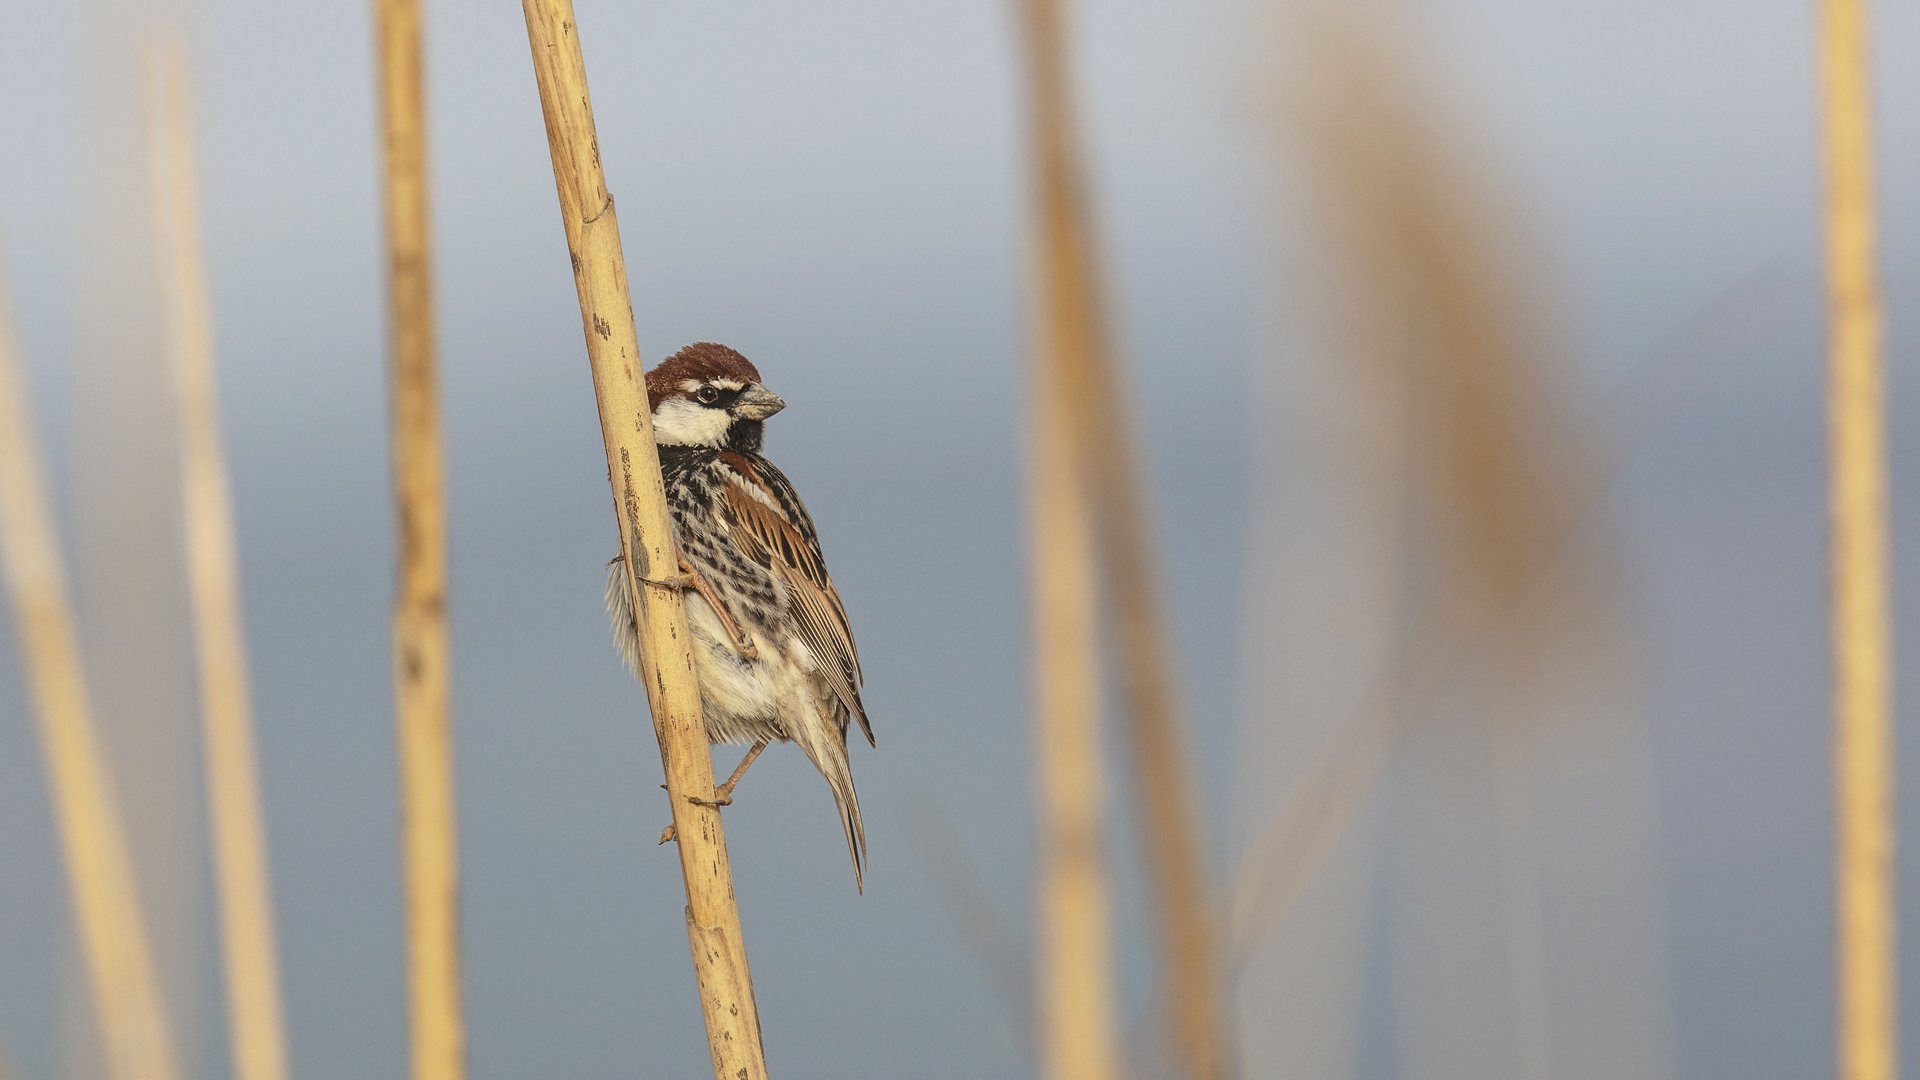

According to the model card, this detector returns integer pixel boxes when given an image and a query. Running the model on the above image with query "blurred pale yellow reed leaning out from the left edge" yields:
[0,244,179,1080]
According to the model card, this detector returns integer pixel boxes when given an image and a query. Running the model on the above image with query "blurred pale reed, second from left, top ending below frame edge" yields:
[146,38,286,1080]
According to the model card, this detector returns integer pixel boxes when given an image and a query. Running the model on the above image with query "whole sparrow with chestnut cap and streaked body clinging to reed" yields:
[607,342,874,892]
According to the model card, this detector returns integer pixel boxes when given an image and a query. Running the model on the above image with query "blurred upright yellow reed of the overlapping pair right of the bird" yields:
[1023,0,1119,1080]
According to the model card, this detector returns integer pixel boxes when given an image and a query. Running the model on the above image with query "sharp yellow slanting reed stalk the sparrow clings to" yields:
[522,0,766,1080]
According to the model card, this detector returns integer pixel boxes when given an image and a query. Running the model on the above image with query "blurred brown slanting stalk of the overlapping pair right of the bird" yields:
[1023,0,1227,1080]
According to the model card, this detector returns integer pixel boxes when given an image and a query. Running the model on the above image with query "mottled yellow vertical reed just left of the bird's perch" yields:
[374,0,467,1080]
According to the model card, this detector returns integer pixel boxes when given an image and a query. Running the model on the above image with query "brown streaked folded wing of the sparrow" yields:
[720,452,874,744]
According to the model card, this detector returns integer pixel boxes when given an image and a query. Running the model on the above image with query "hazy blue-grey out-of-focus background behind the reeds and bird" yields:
[0,0,1920,1080]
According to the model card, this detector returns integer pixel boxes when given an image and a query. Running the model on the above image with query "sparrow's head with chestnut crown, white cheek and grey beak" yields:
[647,342,787,454]
